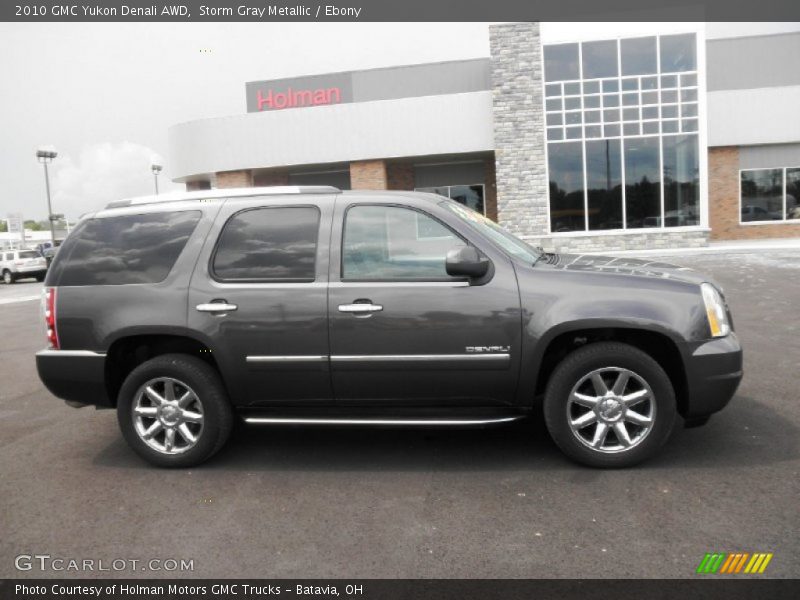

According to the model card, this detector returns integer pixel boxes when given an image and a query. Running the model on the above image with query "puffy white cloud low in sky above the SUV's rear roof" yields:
[52,142,174,219]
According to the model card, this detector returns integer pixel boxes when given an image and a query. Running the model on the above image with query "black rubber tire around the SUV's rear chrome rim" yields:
[117,354,233,468]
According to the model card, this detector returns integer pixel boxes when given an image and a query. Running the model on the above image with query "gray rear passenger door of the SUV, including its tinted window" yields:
[188,194,335,406]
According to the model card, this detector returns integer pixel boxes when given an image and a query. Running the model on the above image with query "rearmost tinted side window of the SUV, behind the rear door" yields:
[52,211,201,286]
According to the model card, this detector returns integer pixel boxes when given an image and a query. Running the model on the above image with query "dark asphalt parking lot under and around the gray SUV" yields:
[0,250,800,578]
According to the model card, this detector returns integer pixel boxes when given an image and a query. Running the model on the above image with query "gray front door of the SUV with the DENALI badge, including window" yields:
[328,195,521,406]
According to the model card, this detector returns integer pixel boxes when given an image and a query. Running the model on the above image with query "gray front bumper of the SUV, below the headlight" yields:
[683,333,742,419]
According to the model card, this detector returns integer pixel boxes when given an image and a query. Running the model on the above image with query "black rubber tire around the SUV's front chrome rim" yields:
[544,342,677,468]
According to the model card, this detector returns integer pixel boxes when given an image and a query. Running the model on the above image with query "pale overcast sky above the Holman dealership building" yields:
[0,23,800,220]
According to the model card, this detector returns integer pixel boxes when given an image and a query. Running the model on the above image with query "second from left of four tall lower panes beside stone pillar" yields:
[586,140,622,229]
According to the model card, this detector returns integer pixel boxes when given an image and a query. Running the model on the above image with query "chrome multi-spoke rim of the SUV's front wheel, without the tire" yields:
[567,367,656,454]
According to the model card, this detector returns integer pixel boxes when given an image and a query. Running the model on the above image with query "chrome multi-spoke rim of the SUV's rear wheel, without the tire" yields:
[131,377,203,454]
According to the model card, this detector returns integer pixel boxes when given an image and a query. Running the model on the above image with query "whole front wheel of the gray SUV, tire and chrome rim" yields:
[544,342,676,468]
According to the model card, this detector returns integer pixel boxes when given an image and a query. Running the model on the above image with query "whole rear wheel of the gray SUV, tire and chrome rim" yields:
[117,354,233,467]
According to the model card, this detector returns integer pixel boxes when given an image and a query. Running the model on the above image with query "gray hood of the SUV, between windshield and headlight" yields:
[539,254,708,287]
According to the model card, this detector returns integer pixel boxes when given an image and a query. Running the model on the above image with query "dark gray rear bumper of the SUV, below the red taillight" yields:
[36,350,112,407]
